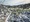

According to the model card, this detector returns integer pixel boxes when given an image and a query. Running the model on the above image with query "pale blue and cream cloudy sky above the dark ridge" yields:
[0,0,30,6]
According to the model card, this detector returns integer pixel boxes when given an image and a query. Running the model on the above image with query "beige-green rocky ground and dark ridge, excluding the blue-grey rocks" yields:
[0,4,30,22]
